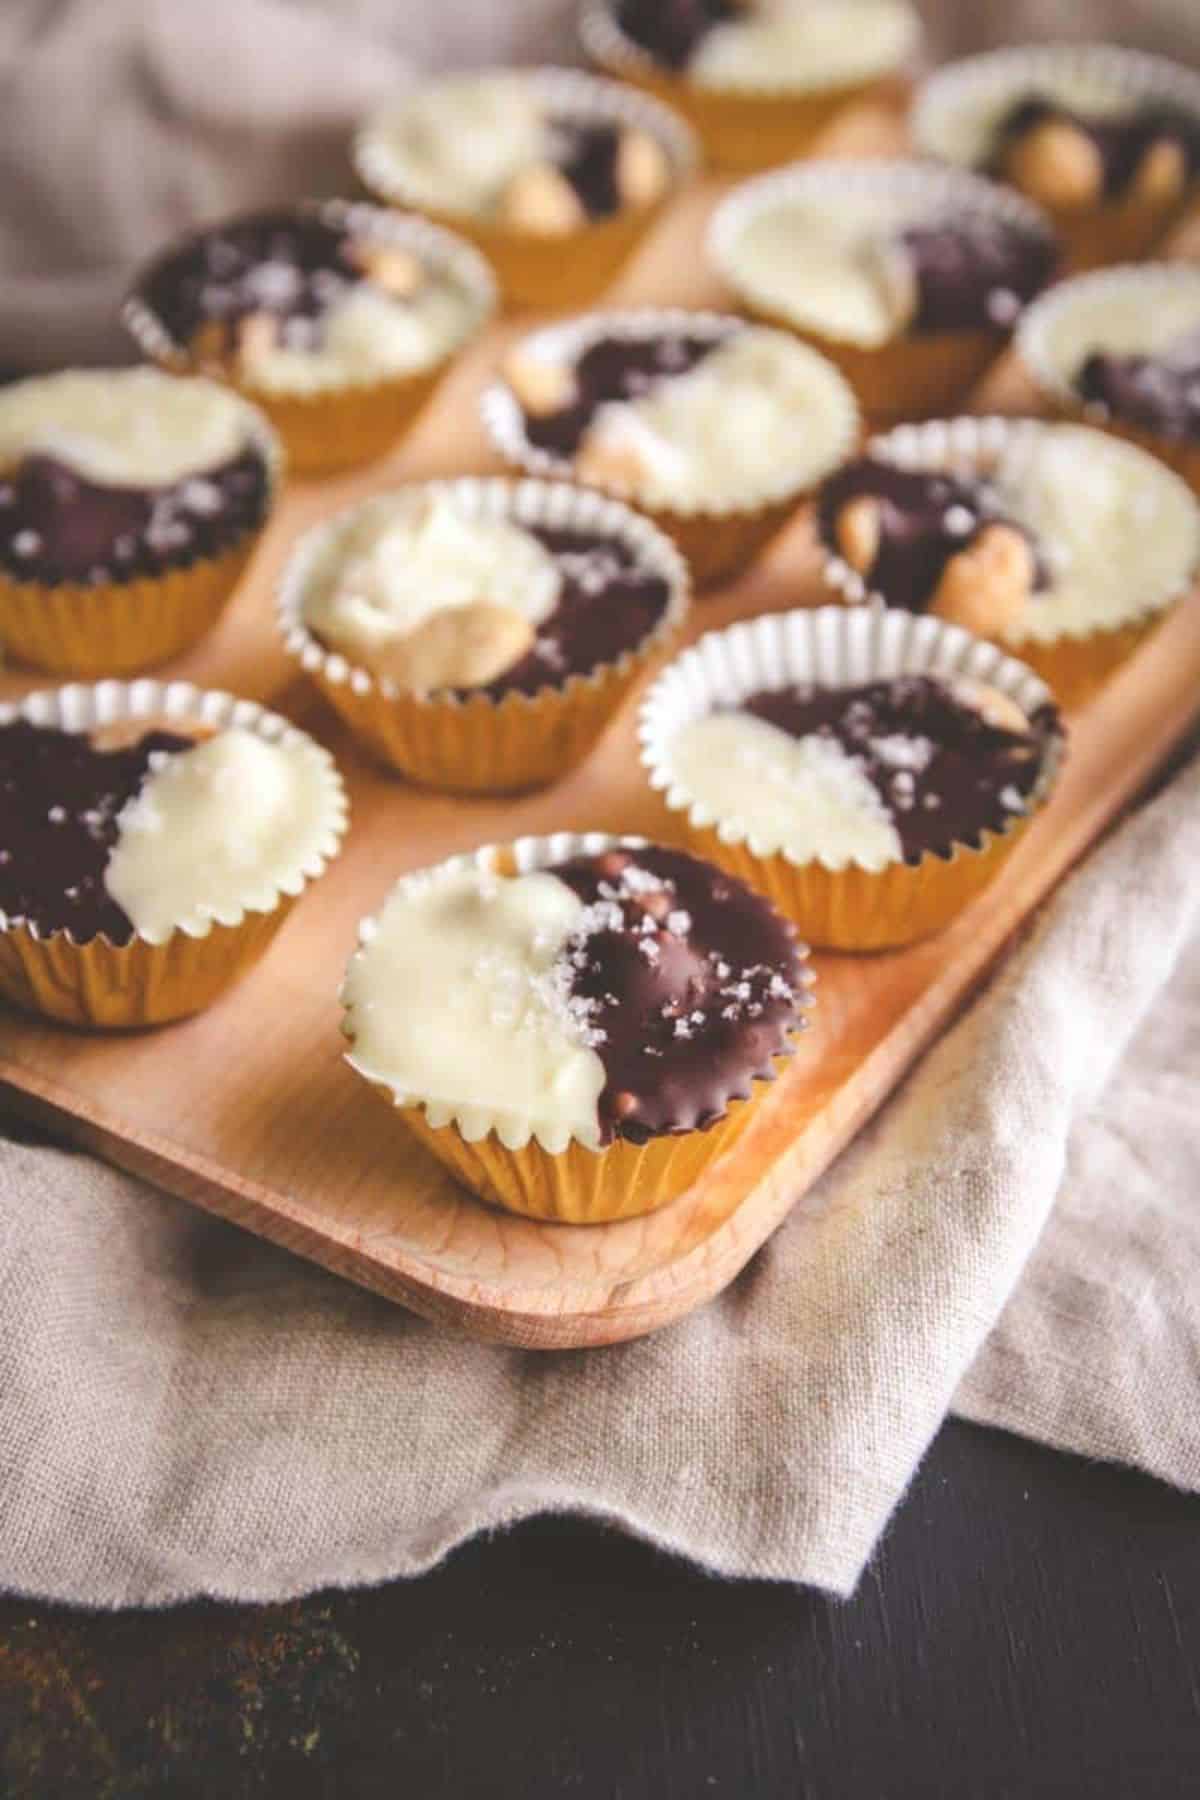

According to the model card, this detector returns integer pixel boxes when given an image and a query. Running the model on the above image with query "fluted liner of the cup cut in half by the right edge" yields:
[1016,263,1200,495]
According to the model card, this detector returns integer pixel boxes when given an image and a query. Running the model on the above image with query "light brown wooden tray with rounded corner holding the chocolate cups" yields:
[0,126,1200,1348]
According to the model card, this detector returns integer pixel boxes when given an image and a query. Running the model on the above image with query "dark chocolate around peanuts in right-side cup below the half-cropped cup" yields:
[817,457,1049,612]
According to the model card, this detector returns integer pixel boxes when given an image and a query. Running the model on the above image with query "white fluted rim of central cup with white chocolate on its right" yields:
[480,306,860,520]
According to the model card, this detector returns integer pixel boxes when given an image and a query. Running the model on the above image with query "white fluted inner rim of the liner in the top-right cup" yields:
[910,43,1200,166]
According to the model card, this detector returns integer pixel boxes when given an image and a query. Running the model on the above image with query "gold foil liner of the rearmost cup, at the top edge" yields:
[579,0,919,171]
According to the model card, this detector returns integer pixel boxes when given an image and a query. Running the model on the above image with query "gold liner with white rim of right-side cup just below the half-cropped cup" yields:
[822,416,1200,713]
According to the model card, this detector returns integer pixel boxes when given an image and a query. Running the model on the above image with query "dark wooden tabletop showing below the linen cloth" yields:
[0,1424,1200,1800]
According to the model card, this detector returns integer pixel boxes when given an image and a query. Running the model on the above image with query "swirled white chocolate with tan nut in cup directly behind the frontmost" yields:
[304,495,561,668]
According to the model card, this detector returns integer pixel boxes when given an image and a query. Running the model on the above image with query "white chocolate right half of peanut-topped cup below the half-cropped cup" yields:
[990,425,1200,644]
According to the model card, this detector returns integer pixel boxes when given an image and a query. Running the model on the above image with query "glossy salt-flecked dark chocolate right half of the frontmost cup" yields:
[551,848,802,1143]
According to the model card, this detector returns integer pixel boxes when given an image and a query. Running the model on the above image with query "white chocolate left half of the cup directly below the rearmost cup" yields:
[736,193,916,347]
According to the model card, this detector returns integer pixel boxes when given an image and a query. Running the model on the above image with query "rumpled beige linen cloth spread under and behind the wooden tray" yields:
[0,0,1200,1606]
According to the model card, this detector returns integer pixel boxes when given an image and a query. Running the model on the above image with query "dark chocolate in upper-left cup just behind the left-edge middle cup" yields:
[139,209,365,349]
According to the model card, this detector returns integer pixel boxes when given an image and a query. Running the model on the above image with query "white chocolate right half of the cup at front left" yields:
[104,727,331,943]
